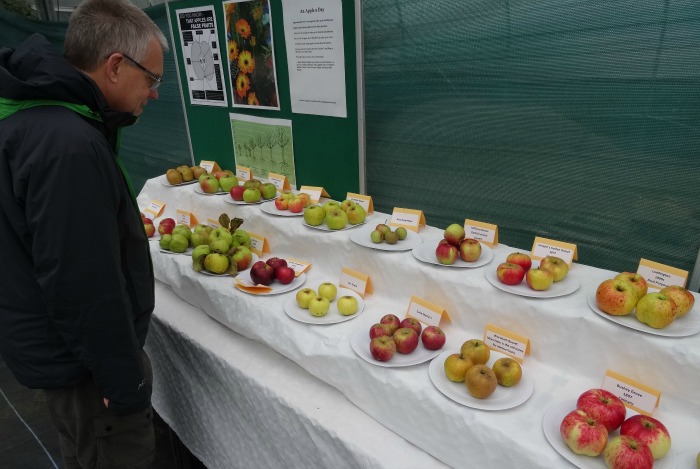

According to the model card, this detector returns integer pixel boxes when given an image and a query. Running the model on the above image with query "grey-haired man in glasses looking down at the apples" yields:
[0,0,167,469]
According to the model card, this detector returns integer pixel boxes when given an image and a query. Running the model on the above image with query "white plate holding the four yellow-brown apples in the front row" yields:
[428,350,535,410]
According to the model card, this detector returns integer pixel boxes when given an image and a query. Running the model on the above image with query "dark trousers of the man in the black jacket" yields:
[46,353,155,469]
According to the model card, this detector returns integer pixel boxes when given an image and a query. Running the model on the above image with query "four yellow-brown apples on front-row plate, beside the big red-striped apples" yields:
[444,339,523,399]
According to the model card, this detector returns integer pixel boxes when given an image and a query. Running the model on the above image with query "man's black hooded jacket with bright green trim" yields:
[0,35,154,414]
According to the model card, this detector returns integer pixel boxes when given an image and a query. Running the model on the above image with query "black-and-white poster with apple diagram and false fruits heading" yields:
[175,5,228,106]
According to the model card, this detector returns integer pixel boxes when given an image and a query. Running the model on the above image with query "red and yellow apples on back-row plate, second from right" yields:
[496,252,569,291]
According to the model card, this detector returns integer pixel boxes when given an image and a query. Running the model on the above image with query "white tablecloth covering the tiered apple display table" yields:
[138,178,700,468]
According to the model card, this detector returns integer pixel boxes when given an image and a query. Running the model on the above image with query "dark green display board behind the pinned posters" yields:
[168,0,364,198]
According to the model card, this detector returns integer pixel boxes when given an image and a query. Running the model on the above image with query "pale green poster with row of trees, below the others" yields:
[229,113,296,187]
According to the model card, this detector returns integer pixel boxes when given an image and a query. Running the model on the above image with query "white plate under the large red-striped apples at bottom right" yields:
[542,400,676,469]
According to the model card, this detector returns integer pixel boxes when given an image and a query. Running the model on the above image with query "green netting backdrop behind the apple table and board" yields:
[0,0,700,280]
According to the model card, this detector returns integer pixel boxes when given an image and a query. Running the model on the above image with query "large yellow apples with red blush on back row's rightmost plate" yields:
[595,272,695,329]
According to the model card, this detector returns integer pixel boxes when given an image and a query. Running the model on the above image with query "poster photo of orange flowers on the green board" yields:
[223,0,280,110]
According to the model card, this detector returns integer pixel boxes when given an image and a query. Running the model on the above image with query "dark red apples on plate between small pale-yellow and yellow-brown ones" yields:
[369,314,446,362]
